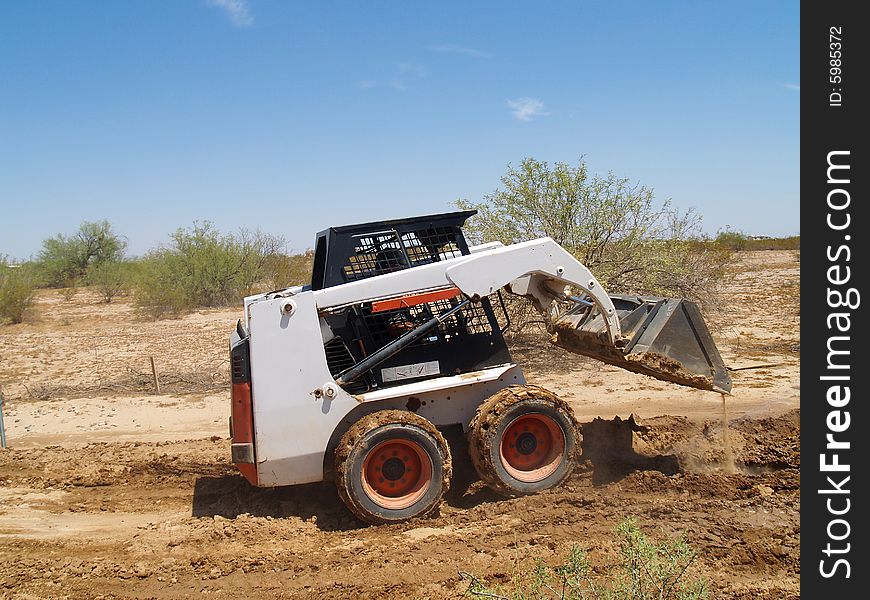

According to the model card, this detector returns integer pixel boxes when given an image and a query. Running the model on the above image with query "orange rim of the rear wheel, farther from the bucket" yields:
[362,439,432,510]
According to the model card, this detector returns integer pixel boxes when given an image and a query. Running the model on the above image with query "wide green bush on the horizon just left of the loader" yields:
[136,221,284,316]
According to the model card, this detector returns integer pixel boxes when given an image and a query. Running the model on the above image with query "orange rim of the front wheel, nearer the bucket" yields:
[499,413,565,483]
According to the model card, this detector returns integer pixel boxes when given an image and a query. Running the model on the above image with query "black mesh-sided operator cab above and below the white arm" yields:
[311,211,511,393]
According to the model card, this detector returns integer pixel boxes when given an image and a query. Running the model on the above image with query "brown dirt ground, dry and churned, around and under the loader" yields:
[0,252,800,598]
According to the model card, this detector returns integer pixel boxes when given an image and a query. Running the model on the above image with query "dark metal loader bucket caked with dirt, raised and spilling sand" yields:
[552,296,731,393]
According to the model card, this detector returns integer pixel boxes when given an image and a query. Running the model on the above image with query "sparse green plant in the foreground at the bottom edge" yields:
[463,518,707,600]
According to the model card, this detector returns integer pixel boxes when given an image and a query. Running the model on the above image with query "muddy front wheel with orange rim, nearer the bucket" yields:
[468,385,580,496]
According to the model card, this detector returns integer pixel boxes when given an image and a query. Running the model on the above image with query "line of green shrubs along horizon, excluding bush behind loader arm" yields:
[0,221,800,323]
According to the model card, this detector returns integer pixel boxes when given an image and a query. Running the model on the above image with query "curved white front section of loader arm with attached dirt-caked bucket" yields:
[447,238,731,393]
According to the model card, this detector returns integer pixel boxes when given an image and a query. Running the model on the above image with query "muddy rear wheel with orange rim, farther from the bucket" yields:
[335,410,452,524]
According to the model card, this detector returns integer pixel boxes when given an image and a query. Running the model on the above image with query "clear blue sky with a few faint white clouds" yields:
[0,0,800,258]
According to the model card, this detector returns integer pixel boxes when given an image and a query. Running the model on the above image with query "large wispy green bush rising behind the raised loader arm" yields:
[457,158,731,330]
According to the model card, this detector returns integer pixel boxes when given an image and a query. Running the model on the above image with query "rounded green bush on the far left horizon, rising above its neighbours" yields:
[37,220,127,287]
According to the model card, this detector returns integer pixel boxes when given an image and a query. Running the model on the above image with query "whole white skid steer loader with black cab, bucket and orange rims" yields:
[230,211,731,523]
